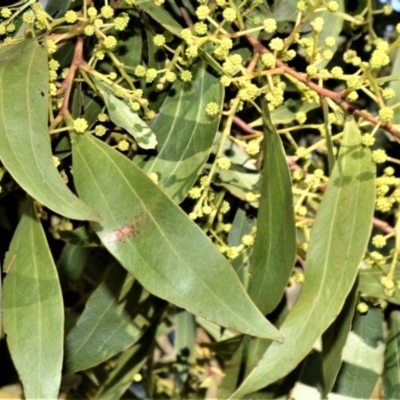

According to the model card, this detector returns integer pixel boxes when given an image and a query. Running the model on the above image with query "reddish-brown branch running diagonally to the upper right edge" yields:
[246,34,400,138]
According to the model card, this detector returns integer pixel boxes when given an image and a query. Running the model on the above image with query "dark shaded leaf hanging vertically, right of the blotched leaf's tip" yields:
[248,102,296,314]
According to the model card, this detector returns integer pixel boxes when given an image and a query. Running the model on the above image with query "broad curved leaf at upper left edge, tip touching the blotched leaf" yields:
[0,40,101,221]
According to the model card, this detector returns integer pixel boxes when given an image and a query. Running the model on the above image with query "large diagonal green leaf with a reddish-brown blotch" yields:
[73,135,280,339]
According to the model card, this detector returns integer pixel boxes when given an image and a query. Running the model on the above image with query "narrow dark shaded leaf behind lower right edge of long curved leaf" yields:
[322,284,358,398]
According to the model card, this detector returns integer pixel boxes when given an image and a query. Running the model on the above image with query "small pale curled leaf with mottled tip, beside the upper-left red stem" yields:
[94,78,157,149]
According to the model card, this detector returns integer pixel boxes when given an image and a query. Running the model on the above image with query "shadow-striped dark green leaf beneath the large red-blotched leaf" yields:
[64,264,161,373]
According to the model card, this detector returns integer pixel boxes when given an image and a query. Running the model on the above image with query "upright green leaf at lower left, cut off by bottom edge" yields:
[3,201,64,399]
